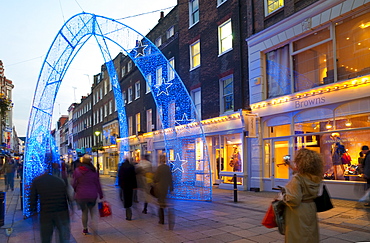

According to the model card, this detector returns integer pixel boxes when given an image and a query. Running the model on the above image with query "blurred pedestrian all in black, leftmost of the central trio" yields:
[118,159,137,220]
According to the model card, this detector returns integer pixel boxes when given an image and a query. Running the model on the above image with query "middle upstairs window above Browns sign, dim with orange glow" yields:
[292,27,334,92]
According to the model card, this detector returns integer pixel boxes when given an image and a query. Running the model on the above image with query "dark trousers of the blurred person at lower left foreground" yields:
[40,210,71,243]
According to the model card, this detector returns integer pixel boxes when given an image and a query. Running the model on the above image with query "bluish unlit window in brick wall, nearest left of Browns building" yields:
[220,75,234,114]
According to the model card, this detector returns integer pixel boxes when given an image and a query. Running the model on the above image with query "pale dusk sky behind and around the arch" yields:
[0,0,177,137]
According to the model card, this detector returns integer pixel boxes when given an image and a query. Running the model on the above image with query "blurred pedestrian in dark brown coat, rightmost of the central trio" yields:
[153,154,173,224]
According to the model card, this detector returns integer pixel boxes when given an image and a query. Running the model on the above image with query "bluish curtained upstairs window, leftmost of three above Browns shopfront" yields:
[266,45,291,98]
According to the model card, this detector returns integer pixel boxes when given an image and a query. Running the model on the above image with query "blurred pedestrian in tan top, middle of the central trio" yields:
[136,154,153,214]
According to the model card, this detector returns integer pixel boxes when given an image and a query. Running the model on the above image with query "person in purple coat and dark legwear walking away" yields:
[72,154,103,235]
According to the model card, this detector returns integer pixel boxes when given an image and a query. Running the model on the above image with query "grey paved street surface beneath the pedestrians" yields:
[0,176,370,243]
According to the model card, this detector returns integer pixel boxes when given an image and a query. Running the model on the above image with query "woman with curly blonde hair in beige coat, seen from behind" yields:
[283,148,323,243]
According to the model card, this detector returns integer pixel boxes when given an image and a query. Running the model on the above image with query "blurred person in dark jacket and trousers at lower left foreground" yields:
[30,169,70,243]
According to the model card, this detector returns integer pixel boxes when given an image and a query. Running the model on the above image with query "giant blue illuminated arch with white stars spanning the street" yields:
[23,13,212,217]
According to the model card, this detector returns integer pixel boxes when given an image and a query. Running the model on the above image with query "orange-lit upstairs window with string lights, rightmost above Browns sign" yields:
[335,12,370,80]
